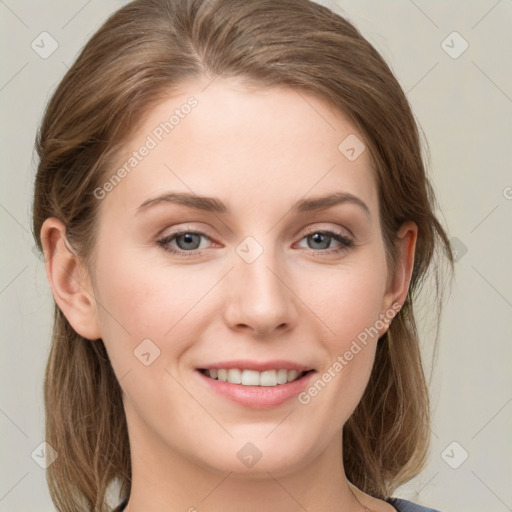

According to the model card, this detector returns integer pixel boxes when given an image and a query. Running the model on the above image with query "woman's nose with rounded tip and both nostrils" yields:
[224,244,299,338]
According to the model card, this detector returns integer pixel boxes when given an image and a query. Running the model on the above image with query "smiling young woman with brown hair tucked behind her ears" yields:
[33,0,453,512]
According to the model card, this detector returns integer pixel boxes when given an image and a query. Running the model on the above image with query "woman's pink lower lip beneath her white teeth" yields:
[196,370,316,409]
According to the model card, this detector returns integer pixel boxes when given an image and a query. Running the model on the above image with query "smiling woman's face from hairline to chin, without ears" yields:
[71,78,408,475]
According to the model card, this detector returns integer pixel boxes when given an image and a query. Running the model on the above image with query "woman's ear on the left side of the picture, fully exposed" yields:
[41,217,101,340]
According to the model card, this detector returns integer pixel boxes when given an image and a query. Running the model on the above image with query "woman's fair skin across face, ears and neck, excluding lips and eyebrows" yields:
[41,79,417,512]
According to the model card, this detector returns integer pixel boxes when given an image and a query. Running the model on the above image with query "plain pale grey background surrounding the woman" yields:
[0,0,512,512]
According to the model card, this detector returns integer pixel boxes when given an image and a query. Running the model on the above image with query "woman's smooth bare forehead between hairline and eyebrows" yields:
[102,78,377,219]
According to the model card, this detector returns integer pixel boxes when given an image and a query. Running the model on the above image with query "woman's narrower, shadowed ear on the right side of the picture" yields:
[379,221,418,336]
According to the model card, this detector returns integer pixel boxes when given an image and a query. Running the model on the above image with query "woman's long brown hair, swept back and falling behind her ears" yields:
[33,0,453,512]
